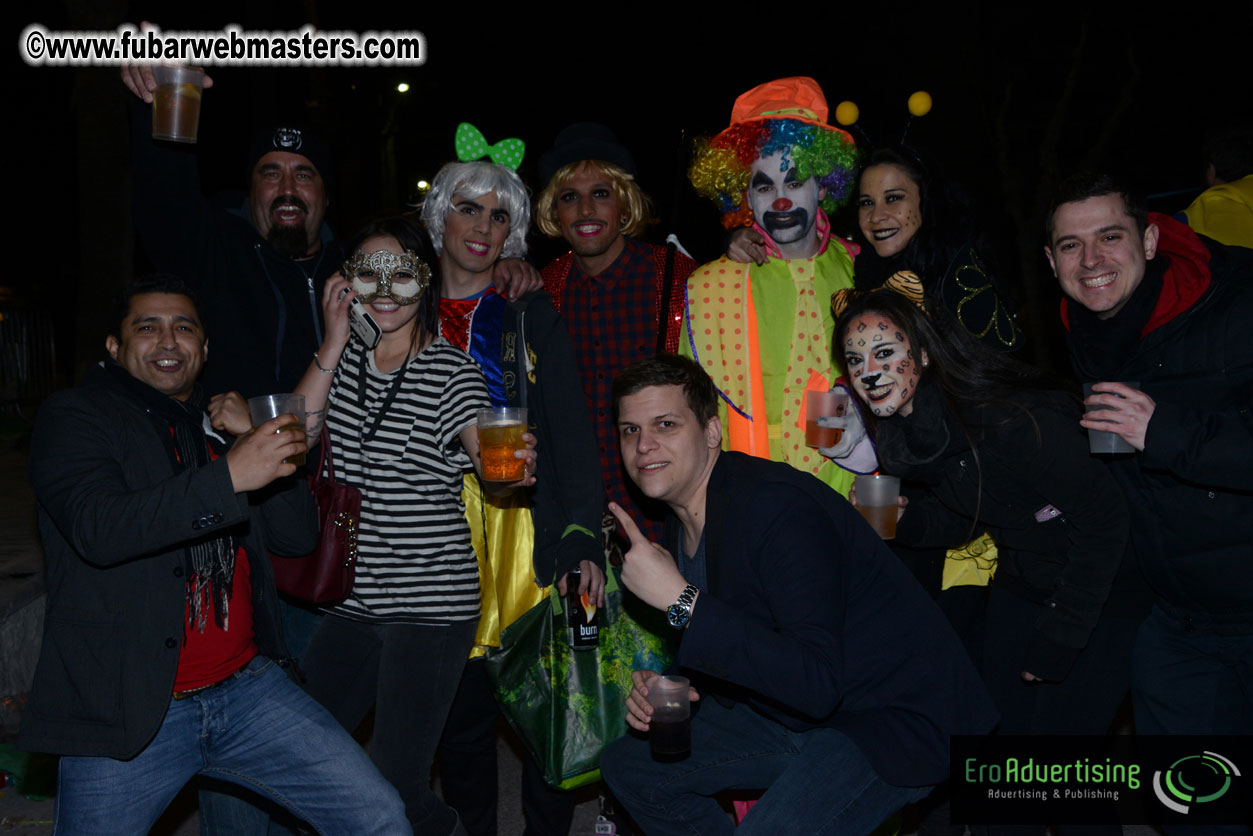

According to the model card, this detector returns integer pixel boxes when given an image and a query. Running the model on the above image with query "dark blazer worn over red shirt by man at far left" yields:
[18,368,317,758]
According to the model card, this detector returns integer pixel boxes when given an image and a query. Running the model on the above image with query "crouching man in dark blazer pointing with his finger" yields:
[600,355,996,836]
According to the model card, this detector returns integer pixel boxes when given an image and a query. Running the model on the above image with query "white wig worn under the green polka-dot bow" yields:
[422,162,531,258]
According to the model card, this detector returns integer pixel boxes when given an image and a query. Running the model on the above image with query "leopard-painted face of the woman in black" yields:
[843,312,927,417]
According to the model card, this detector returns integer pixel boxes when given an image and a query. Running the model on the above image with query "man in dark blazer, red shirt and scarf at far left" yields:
[19,276,408,835]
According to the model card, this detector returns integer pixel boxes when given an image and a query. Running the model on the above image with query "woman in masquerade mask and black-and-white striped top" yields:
[297,218,535,833]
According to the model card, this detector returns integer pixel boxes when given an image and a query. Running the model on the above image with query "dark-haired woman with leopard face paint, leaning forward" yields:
[833,290,1138,762]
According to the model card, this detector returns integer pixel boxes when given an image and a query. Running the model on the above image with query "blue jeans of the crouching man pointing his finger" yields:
[600,697,931,836]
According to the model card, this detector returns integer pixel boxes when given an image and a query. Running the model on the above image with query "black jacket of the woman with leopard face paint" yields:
[878,382,1128,678]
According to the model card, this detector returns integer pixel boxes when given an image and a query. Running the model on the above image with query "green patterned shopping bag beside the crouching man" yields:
[486,568,673,790]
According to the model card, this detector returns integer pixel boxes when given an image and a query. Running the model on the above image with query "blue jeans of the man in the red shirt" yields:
[54,657,411,836]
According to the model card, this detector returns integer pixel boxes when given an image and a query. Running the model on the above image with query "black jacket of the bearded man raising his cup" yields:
[130,99,343,397]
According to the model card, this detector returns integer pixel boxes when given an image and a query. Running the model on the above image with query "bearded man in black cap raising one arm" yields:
[122,65,343,397]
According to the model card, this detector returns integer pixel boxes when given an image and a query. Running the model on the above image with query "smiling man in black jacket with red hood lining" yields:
[1045,175,1253,734]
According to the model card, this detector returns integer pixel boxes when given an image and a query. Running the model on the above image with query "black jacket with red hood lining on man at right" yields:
[1071,216,1253,633]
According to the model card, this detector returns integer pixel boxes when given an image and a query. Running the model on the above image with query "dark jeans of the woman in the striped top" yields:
[302,615,477,836]
